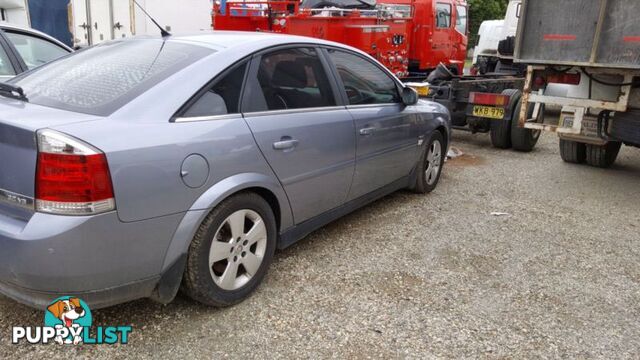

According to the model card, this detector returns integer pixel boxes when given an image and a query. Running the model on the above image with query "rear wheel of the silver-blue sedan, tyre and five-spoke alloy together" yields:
[182,192,277,307]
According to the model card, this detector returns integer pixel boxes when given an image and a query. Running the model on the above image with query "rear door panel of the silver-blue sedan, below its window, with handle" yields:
[245,107,356,223]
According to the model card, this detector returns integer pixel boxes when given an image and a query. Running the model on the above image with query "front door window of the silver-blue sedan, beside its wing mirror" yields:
[329,50,400,105]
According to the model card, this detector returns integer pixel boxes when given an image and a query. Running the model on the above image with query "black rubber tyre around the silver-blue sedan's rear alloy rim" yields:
[181,192,276,307]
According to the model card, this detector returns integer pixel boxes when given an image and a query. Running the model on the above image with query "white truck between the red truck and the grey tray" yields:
[471,0,524,74]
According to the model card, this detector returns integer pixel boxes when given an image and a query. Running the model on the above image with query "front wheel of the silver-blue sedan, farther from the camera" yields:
[412,130,447,194]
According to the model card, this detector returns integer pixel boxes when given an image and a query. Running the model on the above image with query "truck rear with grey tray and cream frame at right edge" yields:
[515,0,640,167]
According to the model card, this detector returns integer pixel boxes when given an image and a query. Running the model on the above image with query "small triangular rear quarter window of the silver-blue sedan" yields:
[182,63,247,117]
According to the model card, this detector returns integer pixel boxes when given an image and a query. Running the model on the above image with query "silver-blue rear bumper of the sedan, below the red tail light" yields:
[0,212,183,308]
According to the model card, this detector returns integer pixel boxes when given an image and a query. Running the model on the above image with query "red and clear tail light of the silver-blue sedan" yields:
[36,130,116,215]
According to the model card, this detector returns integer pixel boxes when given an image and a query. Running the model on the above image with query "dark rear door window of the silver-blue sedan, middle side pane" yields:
[243,48,336,112]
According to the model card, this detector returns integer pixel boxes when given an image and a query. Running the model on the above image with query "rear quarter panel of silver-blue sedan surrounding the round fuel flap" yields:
[53,115,288,222]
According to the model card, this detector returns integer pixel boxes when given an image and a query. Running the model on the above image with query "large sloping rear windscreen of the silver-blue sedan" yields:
[11,39,215,116]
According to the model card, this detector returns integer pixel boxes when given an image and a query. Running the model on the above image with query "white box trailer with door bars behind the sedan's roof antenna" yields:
[69,0,213,47]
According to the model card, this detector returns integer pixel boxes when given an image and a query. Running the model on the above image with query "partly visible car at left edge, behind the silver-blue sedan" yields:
[0,22,73,81]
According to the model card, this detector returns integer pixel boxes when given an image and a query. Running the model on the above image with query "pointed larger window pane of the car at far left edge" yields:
[6,32,69,69]
